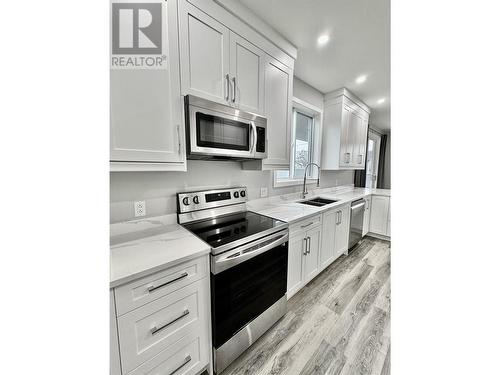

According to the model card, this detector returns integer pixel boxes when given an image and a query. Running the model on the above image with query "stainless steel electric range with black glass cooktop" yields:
[177,187,288,373]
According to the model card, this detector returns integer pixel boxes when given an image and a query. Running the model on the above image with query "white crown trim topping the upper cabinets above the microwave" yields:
[188,0,297,69]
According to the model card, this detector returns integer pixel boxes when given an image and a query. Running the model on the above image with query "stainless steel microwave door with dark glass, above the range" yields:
[189,106,257,159]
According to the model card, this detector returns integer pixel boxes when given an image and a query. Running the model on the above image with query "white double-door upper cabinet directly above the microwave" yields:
[180,1,266,114]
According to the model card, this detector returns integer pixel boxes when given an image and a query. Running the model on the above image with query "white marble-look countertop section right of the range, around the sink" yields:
[247,187,391,223]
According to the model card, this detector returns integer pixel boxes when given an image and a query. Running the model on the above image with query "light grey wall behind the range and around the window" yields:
[110,78,354,223]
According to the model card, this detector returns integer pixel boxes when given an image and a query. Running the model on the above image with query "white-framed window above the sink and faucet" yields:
[274,99,321,187]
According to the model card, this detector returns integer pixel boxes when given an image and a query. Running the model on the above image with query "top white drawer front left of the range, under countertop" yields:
[115,256,208,316]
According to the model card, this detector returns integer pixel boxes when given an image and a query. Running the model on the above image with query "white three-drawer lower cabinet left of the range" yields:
[112,256,211,375]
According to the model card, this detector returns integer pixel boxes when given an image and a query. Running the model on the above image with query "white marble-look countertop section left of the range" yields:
[110,215,210,288]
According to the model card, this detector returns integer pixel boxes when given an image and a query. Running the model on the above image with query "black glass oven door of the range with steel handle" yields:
[211,231,288,348]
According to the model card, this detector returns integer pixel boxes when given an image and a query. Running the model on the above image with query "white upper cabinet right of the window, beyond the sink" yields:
[321,89,370,170]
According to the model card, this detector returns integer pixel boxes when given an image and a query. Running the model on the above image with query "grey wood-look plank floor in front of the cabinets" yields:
[221,237,391,375]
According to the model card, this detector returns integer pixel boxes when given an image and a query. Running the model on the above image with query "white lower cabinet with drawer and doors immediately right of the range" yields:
[287,215,321,299]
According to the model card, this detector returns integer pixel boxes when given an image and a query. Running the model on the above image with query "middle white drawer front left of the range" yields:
[118,278,209,373]
